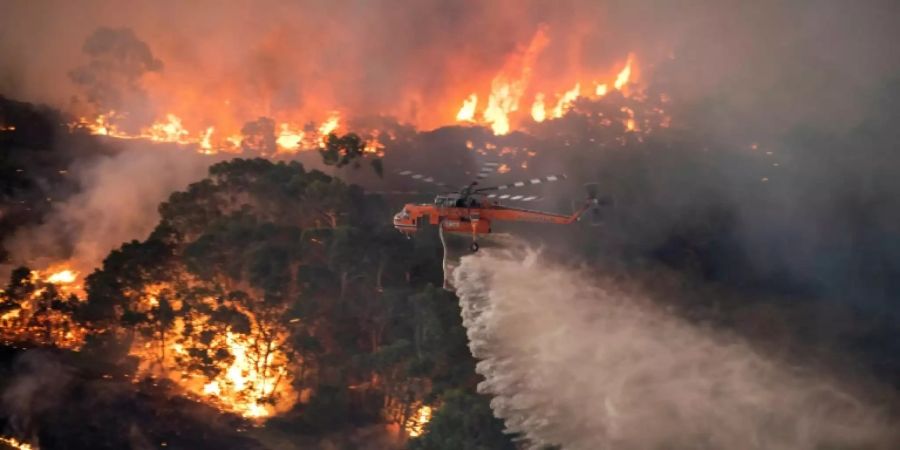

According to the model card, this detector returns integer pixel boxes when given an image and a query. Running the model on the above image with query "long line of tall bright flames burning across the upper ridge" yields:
[67,26,648,146]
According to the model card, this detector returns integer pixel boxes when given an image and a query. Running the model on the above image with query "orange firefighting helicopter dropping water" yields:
[394,163,608,252]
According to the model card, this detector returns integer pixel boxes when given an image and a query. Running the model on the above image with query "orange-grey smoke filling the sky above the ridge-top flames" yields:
[0,0,900,133]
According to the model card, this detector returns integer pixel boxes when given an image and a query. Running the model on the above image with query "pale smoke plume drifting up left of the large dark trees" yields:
[4,142,215,274]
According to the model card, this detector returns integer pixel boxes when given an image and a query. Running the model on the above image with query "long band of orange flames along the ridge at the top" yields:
[69,26,642,154]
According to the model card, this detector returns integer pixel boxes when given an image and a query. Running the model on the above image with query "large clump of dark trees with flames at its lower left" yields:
[67,159,465,432]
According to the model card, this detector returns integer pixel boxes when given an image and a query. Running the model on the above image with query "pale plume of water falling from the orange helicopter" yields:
[454,250,898,449]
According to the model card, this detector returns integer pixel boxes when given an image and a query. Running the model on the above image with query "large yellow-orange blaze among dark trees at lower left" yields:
[131,285,296,419]
